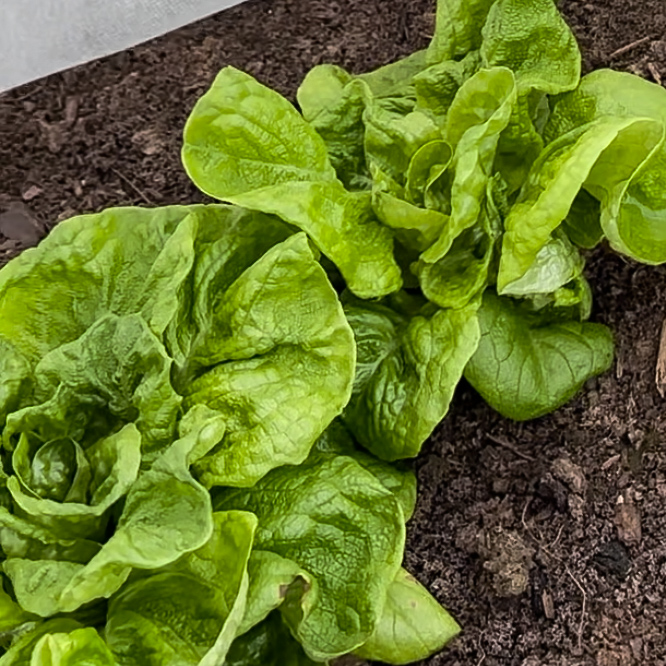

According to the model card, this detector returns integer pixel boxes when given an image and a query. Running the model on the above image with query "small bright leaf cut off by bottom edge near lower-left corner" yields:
[30,627,116,666]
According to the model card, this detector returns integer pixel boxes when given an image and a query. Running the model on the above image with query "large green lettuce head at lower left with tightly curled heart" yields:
[0,205,457,666]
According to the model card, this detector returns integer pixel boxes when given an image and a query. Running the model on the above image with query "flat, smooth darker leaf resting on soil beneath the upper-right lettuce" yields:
[465,292,613,421]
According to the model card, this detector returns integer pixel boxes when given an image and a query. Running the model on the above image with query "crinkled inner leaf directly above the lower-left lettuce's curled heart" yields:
[4,314,181,453]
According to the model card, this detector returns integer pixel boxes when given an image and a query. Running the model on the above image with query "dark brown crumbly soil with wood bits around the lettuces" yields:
[0,0,666,666]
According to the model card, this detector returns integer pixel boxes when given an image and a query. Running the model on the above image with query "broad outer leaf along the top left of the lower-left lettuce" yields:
[0,206,200,364]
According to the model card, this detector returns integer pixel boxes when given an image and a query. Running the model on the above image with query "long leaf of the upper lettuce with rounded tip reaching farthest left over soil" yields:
[182,67,400,298]
